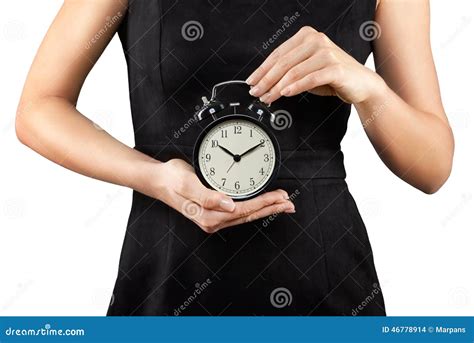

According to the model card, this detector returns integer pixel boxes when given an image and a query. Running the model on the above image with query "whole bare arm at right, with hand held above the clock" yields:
[248,0,454,194]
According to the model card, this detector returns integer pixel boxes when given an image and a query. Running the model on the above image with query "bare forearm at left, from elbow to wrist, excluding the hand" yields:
[16,97,158,198]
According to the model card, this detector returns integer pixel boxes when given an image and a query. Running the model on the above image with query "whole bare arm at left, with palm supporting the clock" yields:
[16,0,294,232]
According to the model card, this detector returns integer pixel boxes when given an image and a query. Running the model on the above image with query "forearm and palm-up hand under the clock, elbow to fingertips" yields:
[16,97,295,233]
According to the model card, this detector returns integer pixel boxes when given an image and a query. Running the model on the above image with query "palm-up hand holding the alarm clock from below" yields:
[146,159,295,233]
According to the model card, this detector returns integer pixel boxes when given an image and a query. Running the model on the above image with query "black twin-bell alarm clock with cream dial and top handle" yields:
[193,80,281,200]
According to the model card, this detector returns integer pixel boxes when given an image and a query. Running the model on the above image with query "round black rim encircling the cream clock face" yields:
[193,113,281,201]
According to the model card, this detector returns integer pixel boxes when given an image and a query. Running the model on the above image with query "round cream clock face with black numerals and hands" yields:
[197,117,277,199]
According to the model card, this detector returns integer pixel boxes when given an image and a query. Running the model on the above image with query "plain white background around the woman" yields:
[0,0,474,316]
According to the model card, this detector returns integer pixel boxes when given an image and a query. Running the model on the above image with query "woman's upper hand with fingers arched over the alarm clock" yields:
[247,26,383,104]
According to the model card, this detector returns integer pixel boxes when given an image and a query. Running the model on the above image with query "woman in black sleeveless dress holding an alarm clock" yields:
[16,0,454,315]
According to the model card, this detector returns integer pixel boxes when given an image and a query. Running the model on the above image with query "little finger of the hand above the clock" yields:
[281,65,342,96]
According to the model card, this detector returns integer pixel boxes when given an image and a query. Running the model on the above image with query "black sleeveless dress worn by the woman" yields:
[107,0,385,315]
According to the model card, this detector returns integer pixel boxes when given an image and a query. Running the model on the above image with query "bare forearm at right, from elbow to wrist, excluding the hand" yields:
[355,79,454,193]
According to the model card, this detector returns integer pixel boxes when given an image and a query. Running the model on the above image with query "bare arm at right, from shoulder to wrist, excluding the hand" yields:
[362,0,454,193]
